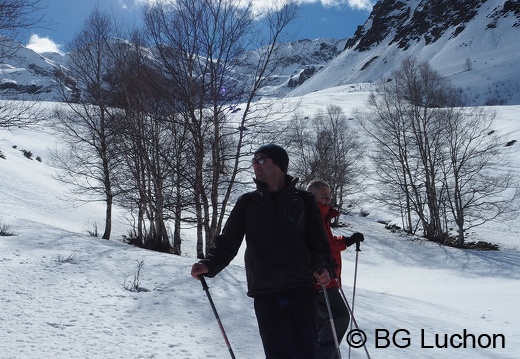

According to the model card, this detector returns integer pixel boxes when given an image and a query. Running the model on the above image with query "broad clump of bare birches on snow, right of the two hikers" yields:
[359,58,517,246]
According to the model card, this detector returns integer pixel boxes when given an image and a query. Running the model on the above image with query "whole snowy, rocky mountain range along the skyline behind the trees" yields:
[0,0,520,105]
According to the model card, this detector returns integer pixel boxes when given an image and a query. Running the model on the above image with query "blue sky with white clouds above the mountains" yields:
[22,0,375,52]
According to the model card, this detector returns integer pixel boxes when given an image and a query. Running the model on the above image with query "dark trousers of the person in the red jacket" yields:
[316,288,350,359]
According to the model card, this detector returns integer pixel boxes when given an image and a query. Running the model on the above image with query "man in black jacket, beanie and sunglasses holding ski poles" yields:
[191,144,331,359]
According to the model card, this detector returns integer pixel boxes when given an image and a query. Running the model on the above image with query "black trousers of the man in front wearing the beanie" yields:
[254,286,318,359]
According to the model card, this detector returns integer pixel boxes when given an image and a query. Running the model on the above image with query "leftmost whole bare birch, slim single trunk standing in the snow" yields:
[54,7,123,239]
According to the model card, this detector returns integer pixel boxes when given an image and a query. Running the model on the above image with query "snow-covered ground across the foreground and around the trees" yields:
[0,92,520,359]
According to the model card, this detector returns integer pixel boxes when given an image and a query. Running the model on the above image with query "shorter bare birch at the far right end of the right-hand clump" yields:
[443,107,520,247]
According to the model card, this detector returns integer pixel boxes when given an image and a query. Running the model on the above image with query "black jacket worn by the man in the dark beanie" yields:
[201,175,331,297]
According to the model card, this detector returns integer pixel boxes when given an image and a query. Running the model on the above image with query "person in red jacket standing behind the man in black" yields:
[307,179,364,359]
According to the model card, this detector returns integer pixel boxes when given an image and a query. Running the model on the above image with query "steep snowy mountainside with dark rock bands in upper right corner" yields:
[292,0,520,105]
